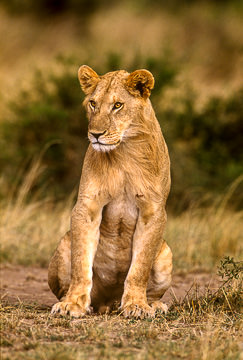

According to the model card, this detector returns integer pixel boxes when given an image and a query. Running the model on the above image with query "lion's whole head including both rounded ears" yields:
[79,65,154,152]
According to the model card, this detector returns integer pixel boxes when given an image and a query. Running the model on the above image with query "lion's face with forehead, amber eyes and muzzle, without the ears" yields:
[86,72,137,151]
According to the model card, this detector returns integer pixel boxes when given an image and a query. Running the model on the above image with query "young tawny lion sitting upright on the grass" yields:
[48,65,172,318]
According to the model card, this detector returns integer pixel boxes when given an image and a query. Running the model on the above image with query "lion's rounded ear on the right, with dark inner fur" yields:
[126,69,154,99]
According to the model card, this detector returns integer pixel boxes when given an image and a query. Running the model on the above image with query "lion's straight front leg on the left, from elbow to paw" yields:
[52,199,102,317]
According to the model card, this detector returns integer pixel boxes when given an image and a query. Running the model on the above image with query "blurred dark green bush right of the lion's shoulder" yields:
[163,88,243,208]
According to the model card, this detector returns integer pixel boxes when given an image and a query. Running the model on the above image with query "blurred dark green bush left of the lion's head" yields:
[0,58,87,197]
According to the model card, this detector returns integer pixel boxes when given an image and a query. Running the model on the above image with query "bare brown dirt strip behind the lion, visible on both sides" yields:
[0,265,220,308]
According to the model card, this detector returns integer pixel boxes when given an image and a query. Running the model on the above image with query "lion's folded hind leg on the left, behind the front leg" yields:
[48,232,71,300]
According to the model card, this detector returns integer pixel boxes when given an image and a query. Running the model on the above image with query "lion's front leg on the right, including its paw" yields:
[121,204,166,318]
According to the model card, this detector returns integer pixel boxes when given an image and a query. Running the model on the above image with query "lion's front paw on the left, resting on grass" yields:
[51,301,92,318]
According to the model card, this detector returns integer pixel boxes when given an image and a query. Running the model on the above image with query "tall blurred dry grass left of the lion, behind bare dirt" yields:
[0,155,73,266]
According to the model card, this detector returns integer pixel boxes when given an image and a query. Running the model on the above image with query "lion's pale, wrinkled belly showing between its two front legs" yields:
[94,194,138,285]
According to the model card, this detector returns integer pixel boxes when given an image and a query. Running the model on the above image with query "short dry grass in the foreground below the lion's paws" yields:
[1,276,243,360]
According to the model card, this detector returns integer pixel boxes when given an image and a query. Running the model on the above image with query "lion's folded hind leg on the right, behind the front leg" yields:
[147,241,172,313]
